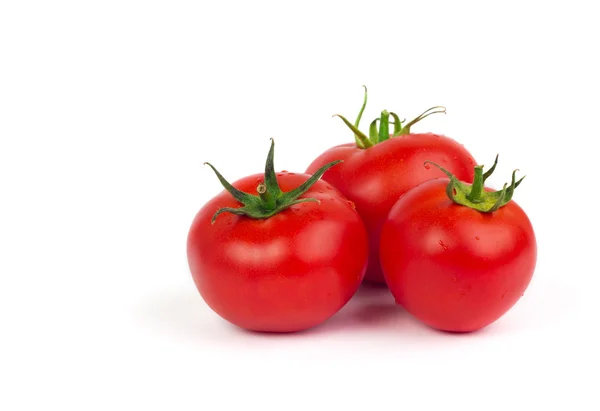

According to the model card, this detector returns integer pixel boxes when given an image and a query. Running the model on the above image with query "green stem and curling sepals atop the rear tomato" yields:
[334,86,446,149]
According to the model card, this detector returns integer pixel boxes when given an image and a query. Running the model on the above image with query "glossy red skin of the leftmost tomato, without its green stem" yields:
[187,173,368,332]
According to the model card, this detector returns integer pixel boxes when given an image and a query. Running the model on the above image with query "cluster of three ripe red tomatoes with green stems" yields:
[187,88,537,332]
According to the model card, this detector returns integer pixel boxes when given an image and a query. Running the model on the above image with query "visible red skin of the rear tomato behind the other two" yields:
[307,133,475,284]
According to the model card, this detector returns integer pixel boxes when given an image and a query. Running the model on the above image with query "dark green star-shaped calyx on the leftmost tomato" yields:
[204,139,342,224]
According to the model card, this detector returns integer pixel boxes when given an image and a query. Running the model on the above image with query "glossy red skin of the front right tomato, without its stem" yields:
[380,178,537,332]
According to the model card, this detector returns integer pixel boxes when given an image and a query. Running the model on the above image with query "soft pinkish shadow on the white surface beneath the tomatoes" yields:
[136,284,506,346]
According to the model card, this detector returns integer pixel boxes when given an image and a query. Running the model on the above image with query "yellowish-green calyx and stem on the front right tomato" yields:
[425,155,525,213]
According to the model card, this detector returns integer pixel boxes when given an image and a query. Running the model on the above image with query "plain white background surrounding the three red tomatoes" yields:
[0,0,600,411]
